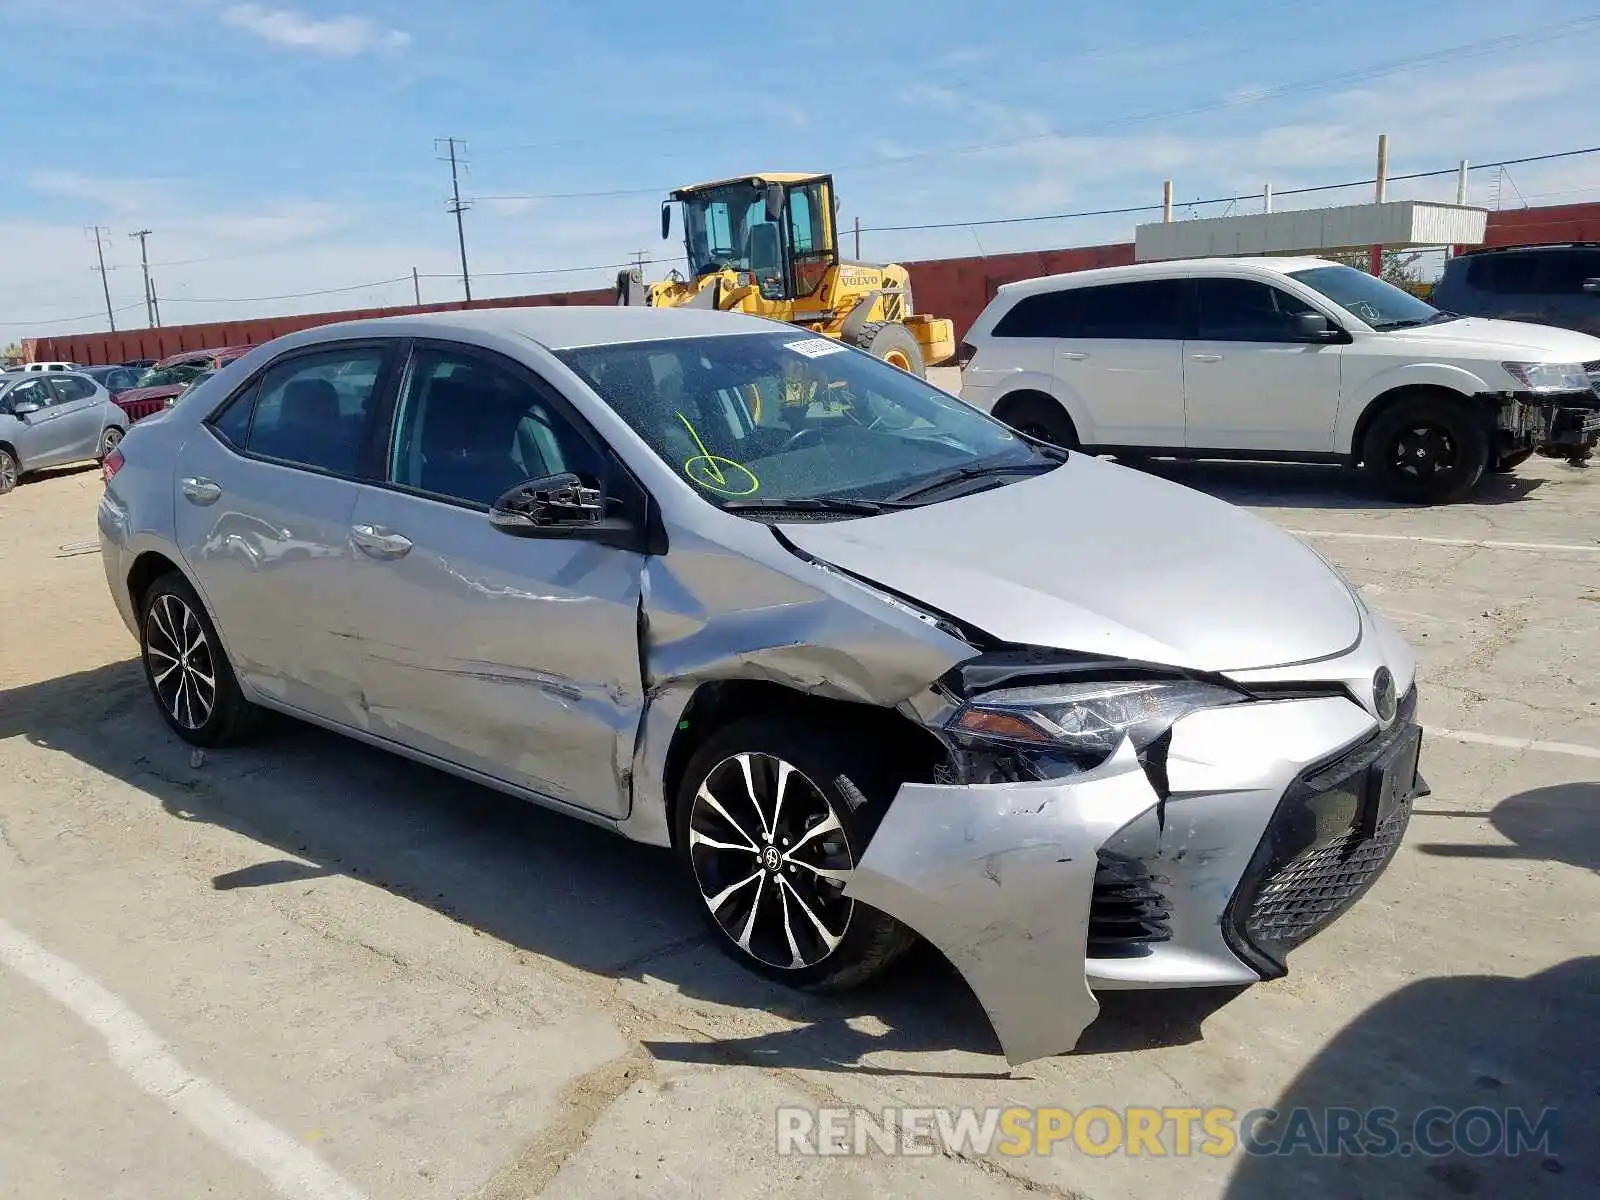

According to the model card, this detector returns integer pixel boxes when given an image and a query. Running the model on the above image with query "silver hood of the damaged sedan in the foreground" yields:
[779,454,1362,672]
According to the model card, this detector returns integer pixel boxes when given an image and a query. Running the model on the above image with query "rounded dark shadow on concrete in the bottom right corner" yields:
[1224,957,1600,1200]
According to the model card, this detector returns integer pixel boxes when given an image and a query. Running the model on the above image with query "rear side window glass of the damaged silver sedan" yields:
[235,346,384,475]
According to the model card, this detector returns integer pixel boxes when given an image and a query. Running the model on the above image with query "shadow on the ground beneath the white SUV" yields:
[1126,459,1544,510]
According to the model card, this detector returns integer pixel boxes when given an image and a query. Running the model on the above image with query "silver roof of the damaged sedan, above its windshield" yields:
[291,304,790,350]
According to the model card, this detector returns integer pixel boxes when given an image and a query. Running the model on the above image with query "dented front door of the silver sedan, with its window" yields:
[350,341,645,818]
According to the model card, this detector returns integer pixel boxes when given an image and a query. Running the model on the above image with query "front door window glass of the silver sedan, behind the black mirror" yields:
[389,349,606,506]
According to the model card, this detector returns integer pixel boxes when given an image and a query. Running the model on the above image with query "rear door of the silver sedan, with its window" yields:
[173,339,392,728]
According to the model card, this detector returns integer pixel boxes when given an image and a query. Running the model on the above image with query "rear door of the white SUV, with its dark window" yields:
[1056,278,1186,446]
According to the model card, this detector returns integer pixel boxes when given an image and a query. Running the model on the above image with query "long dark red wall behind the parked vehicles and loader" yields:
[22,203,1600,365]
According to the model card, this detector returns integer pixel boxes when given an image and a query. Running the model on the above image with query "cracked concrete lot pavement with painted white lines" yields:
[0,416,1600,1200]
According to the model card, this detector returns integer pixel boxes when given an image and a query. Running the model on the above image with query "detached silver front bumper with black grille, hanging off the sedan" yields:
[846,691,1421,1066]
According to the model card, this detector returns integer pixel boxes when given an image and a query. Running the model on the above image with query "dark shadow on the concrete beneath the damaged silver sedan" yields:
[0,661,1235,1078]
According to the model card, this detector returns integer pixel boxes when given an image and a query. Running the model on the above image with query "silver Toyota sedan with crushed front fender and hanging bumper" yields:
[99,307,1426,1062]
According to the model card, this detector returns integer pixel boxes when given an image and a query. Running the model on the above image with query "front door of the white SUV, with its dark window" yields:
[1182,277,1344,453]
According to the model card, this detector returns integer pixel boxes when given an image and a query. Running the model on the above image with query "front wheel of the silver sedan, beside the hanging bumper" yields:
[674,717,915,990]
